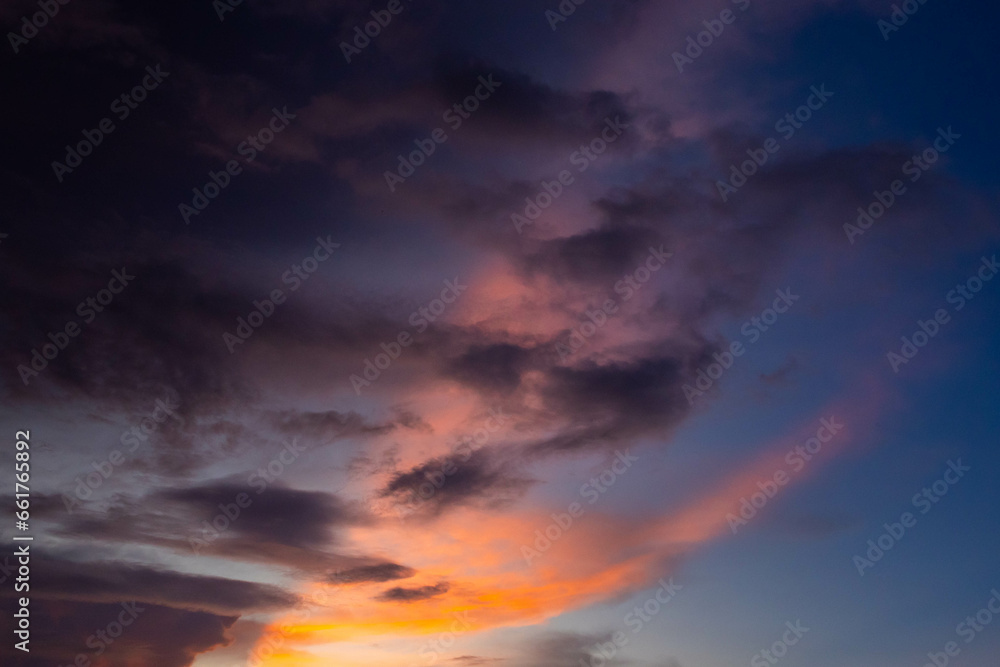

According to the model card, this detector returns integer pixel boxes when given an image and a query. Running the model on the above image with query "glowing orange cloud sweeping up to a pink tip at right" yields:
[252,392,877,665]
